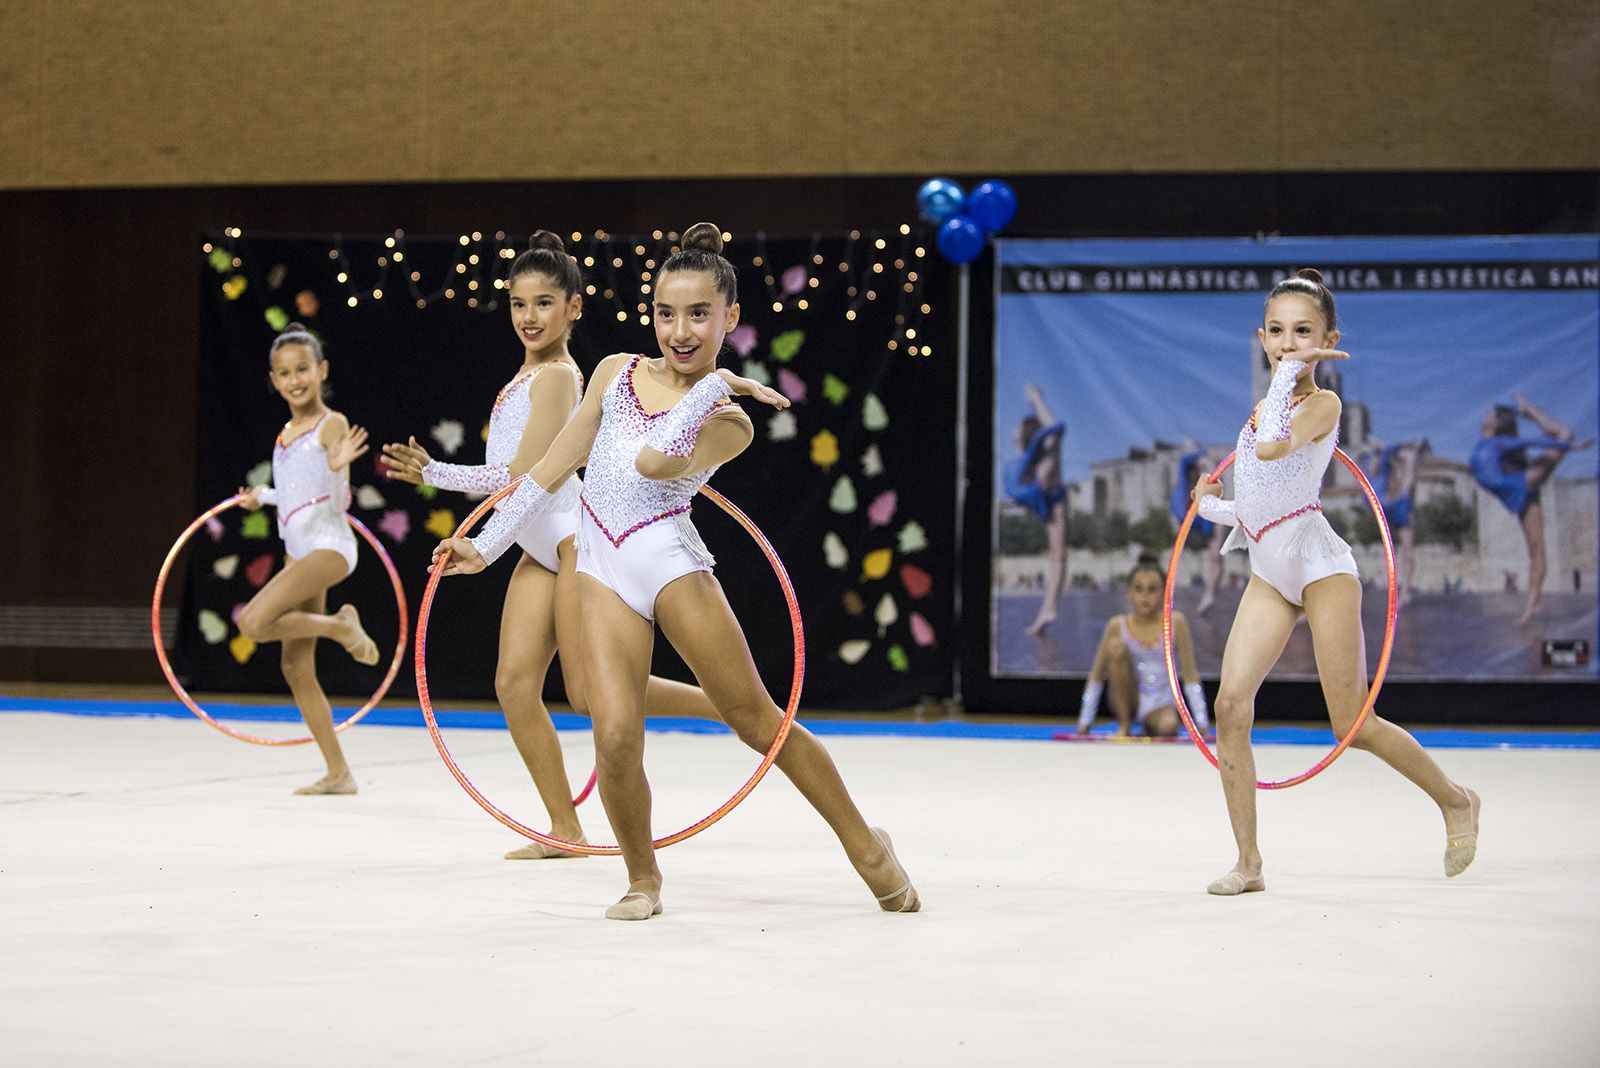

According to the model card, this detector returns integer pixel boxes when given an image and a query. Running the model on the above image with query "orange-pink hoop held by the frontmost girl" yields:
[416,475,805,857]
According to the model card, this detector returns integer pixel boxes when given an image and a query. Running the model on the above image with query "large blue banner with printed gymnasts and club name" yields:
[990,235,1600,679]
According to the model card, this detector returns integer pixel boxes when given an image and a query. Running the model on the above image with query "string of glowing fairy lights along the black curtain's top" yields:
[200,224,933,357]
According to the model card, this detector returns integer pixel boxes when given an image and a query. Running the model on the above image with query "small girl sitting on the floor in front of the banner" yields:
[1078,553,1211,739]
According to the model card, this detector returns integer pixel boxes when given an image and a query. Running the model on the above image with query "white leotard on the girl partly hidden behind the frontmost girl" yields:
[422,363,584,571]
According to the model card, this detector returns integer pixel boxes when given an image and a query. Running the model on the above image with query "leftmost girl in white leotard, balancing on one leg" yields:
[238,323,378,795]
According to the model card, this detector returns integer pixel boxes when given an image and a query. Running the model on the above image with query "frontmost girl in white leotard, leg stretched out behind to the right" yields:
[435,222,922,919]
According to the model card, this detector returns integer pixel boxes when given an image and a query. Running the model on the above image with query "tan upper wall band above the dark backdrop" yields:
[0,0,1600,189]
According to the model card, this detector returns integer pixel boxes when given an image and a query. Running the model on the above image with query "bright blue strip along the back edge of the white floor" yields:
[0,697,1600,750]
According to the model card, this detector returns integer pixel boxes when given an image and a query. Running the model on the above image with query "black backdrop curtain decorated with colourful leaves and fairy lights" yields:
[174,230,955,708]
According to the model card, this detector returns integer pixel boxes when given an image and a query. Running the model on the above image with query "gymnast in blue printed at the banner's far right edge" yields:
[1470,393,1594,625]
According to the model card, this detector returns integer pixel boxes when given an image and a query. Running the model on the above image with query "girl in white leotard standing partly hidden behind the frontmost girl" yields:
[384,230,717,860]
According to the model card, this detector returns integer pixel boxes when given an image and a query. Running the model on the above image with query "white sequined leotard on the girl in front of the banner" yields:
[1200,360,1357,604]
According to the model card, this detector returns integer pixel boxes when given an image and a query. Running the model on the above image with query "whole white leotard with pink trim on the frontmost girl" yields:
[578,357,718,619]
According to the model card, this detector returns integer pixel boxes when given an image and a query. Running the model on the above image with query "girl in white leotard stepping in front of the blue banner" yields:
[1195,269,1478,895]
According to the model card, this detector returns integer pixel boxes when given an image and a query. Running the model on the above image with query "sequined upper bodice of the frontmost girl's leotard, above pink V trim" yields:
[582,357,729,545]
